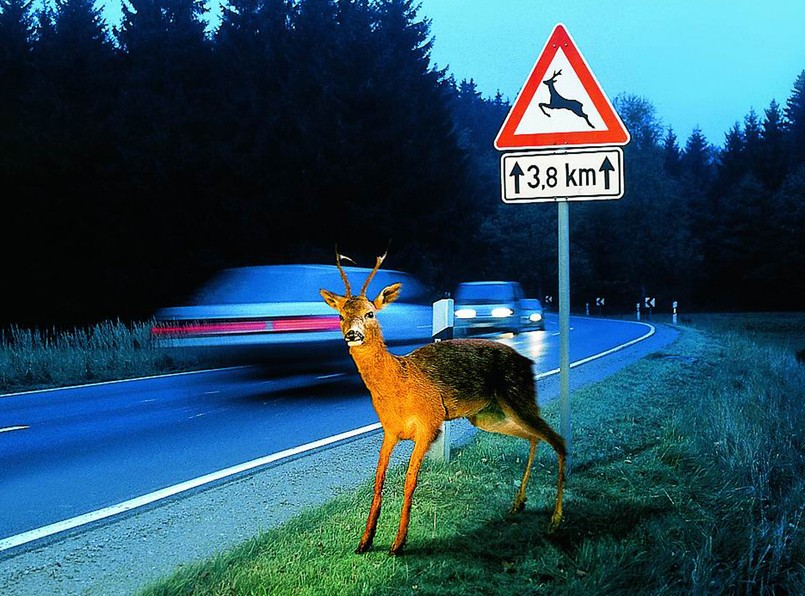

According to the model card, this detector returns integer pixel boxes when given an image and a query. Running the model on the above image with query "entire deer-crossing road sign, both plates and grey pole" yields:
[495,23,630,480]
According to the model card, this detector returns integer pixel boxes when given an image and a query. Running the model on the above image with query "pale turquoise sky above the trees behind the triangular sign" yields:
[419,0,805,145]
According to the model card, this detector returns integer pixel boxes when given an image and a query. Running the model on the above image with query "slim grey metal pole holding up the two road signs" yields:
[557,200,573,475]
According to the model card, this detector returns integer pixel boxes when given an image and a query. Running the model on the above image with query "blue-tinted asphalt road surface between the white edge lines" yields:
[0,315,649,542]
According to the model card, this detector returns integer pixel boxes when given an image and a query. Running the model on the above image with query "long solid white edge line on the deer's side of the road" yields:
[0,321,656,552]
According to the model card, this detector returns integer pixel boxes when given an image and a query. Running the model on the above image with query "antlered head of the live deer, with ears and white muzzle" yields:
[320,247,402,348]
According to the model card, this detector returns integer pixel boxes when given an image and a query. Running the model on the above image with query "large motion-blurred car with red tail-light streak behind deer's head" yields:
[151,265,432,373]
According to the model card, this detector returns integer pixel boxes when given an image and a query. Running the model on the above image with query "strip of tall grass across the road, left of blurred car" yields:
[0,321,195,393]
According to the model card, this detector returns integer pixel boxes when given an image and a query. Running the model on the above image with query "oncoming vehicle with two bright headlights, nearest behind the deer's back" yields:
[453,281,524,337]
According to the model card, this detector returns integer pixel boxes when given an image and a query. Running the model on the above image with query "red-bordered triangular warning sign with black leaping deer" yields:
[495,24,629,149]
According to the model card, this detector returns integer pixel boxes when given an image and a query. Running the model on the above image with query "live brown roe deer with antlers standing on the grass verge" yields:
[321,248,565,555]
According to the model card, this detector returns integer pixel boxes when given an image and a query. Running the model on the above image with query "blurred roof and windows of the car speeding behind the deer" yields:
[192,265,427,304]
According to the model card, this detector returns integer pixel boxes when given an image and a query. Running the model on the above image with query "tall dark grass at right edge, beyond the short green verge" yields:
[679,333,805,593]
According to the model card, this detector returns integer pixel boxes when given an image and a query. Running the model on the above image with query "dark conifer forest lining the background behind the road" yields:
[0,0,805,326]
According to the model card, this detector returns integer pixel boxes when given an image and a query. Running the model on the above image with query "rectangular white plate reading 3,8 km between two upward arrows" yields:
[500,147,624,203]
